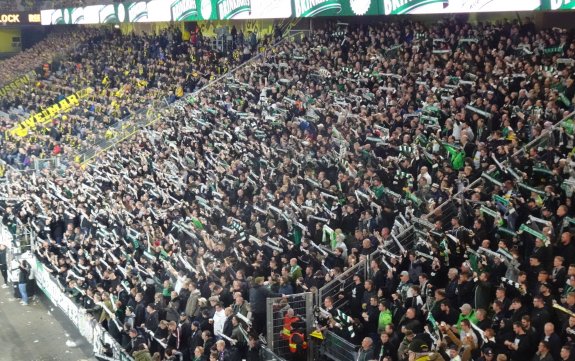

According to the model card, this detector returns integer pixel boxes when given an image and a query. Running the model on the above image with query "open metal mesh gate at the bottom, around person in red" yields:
[266,292,314,361]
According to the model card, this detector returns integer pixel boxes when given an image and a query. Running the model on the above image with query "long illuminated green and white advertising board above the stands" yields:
[39,0,575,25]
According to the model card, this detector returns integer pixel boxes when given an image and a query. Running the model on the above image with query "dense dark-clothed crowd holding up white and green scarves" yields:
[2,19,575,361]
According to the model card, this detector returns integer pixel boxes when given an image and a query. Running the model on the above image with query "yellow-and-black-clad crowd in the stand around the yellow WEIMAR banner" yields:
[0,29,260,169]
